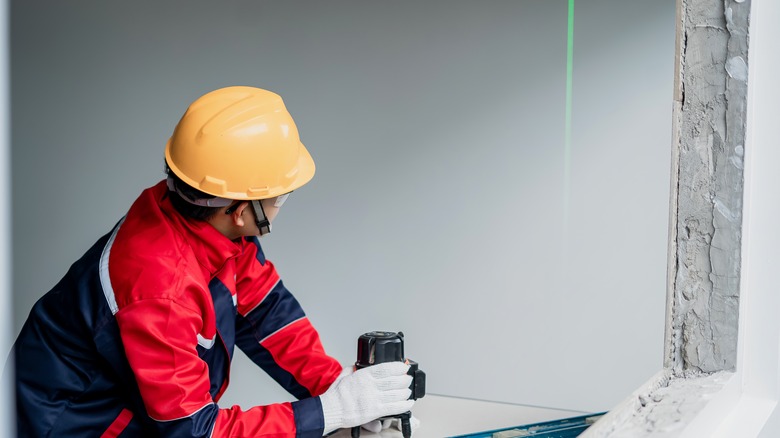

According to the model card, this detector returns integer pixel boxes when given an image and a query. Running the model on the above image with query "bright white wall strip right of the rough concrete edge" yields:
[740,0,780,438]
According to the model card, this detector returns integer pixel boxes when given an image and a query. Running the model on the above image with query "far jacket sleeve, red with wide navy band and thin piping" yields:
[236,237,342,400]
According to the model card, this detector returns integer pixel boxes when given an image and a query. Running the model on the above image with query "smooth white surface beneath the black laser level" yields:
[331,394,584,438]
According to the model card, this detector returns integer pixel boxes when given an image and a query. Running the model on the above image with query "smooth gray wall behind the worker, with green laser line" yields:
[11,0,674,411]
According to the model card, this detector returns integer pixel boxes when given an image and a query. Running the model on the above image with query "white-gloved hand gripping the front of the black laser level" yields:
[320,362,414,434]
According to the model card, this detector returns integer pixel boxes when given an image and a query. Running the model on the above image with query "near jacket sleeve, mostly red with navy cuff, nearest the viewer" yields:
[116,298,324,438]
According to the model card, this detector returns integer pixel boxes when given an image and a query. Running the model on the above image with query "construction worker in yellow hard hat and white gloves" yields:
[14,86,413,438]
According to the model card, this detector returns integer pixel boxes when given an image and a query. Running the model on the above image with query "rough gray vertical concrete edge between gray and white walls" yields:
[664,0,750,374]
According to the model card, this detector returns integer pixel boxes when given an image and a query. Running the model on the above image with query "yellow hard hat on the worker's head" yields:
[165,86,314,200]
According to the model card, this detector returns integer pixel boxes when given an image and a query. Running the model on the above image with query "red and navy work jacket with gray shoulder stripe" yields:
[14,182,342,438]
